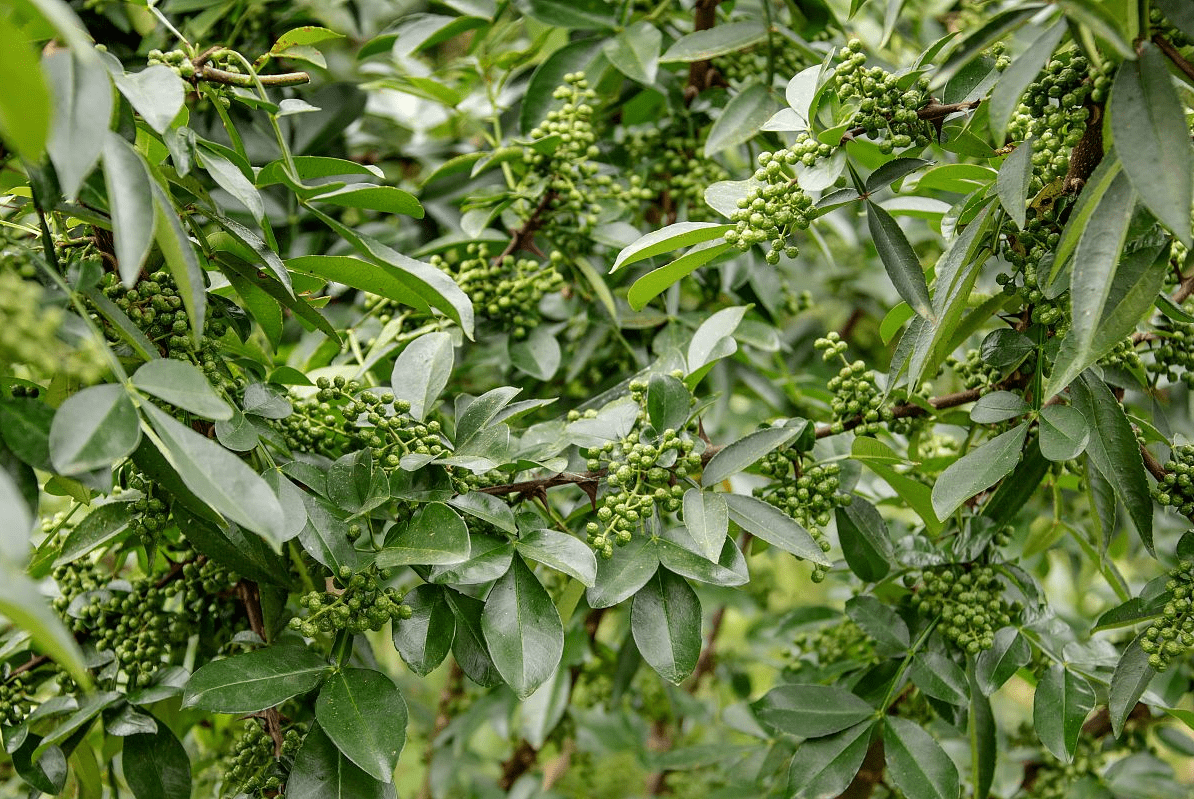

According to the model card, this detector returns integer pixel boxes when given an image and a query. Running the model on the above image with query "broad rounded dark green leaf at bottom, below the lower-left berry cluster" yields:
[315,669,406,782]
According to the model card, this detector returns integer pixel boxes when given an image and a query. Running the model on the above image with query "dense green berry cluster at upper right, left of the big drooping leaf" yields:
[1008,49,1110,193]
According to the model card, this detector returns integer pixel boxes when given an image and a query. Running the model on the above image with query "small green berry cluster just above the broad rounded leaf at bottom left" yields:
[289,566,411,638]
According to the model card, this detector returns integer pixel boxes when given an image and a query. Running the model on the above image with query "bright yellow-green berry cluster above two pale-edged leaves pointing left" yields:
[725,134,833,264]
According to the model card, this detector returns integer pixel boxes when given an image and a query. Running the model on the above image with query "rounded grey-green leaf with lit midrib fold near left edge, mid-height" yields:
[49,383,141,474]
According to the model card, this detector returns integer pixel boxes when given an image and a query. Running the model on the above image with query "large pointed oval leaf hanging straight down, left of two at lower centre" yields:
[481,557,564,699]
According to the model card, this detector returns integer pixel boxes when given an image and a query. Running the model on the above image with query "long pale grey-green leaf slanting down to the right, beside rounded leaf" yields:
[142,402,287,545]
